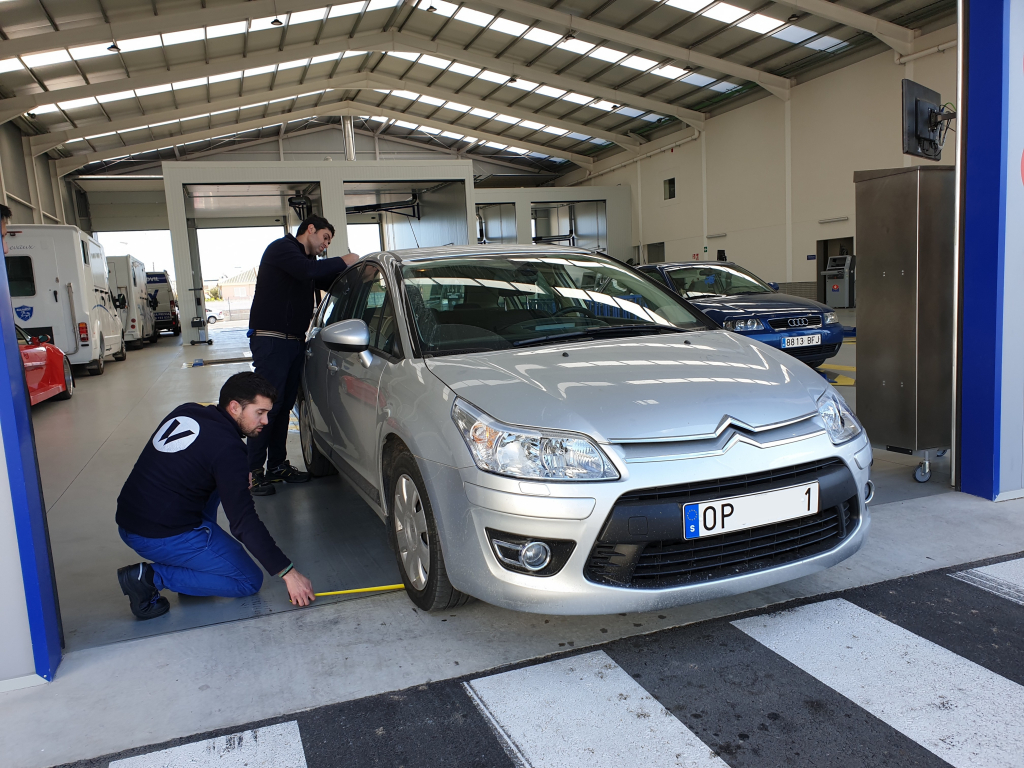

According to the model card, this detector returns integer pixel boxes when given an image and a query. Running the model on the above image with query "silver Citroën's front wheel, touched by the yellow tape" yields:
[387,451,470,611]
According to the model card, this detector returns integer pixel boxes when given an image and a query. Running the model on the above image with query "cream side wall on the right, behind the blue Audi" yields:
[558,27,956,283]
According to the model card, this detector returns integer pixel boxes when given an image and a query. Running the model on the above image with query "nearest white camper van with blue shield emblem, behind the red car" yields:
[6,224,127,375]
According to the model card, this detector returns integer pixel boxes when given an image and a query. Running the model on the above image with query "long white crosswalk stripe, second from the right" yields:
[732,600,1024,768]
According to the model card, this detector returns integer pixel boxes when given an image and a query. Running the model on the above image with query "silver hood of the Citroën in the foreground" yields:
[427,331,826,442]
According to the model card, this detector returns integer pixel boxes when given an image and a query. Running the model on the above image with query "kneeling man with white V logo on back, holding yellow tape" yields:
[117,373,314,618]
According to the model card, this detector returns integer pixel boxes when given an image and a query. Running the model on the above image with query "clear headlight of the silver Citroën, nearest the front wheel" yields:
[452,399,618,480]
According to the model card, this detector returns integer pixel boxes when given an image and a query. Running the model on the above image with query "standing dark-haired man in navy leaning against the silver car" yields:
[249,216,359,496]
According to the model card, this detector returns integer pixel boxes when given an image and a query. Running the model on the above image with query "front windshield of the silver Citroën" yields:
[401,254,706,355]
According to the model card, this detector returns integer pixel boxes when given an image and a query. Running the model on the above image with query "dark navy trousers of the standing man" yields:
[249,336,305,471]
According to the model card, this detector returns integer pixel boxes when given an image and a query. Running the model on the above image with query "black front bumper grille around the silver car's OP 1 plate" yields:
[584,460,859,589]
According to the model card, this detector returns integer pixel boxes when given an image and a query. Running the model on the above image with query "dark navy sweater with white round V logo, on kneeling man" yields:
[117,402,291,574]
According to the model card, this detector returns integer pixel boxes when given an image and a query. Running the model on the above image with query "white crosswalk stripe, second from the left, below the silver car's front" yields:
[463,651,727,768]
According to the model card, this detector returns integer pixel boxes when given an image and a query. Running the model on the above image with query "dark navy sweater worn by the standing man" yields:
[249,234,347,336]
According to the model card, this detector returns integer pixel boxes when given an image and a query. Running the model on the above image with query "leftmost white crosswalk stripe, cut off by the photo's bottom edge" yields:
[110,720,306,768]
